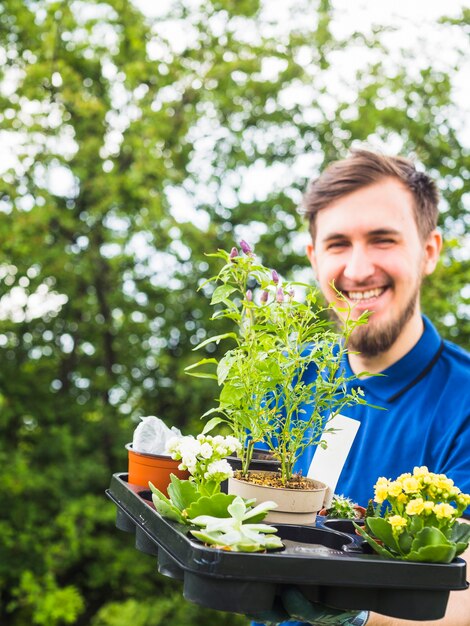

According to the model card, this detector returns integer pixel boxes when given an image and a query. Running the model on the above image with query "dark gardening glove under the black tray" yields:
[251,586,369,626]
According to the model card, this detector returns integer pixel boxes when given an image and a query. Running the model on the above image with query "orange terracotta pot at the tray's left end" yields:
[126,443,189,495]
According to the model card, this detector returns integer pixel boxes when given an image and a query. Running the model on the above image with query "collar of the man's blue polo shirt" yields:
[345,316,442,402]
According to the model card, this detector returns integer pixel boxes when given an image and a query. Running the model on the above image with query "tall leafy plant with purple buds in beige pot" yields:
[186,242,367,523]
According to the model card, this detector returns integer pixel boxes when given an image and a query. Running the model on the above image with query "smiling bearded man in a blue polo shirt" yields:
[297,150,470,626]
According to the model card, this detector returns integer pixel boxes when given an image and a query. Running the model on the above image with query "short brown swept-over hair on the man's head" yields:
[301,149,439,241]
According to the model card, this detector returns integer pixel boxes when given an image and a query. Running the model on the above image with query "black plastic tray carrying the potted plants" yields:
[106,474,467,620]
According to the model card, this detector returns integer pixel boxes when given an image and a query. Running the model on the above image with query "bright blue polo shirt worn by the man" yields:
[295,318,470,517]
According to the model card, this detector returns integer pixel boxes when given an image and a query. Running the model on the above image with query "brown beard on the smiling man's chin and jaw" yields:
[348,281,421,357]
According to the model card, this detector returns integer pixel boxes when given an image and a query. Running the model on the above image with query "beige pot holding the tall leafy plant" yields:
[228,471,327,525]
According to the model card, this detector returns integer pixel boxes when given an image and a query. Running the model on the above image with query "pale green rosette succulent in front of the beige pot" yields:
[191,496,283,552]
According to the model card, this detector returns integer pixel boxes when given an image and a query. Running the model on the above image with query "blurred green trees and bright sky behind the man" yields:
[0,0,470,626]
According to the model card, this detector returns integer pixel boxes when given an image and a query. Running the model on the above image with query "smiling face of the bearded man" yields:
[307,178,441,356]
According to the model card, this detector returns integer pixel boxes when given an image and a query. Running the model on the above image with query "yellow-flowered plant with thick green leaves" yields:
[355,467,470,563]
